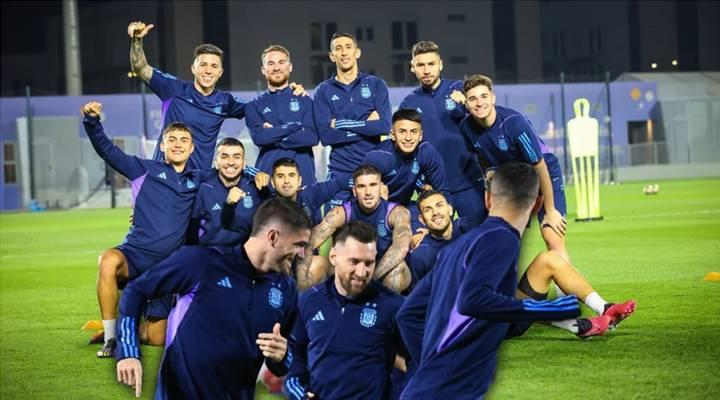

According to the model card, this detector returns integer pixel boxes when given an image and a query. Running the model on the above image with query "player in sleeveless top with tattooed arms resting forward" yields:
[297,165,411,293]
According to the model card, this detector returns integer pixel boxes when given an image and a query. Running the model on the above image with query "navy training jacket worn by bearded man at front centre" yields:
[284,276,403,399]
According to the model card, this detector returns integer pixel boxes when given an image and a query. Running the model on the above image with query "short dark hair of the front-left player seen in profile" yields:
[250,197,312,236]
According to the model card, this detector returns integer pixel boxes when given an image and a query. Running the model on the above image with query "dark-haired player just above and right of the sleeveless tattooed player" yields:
[362,109,447,206]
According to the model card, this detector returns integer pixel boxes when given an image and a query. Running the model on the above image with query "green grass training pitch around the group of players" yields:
[0,179,720,400]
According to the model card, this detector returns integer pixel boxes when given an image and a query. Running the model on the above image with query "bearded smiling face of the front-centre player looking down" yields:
[329,237,377,297]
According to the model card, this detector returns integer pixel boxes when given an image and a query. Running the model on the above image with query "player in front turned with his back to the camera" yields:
[396,162,580,399]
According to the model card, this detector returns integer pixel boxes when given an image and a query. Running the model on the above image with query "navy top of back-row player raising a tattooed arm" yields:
[147,68,245,169]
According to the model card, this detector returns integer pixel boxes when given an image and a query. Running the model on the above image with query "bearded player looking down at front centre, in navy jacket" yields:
[285,221,403,400]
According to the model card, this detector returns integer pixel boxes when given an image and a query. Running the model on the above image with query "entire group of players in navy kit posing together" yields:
[82,22,635,399]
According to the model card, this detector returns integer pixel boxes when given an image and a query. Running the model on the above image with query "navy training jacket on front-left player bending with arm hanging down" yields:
[117,246,297,399]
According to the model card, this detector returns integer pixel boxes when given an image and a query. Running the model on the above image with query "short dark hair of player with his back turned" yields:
[487,161,540,211]
